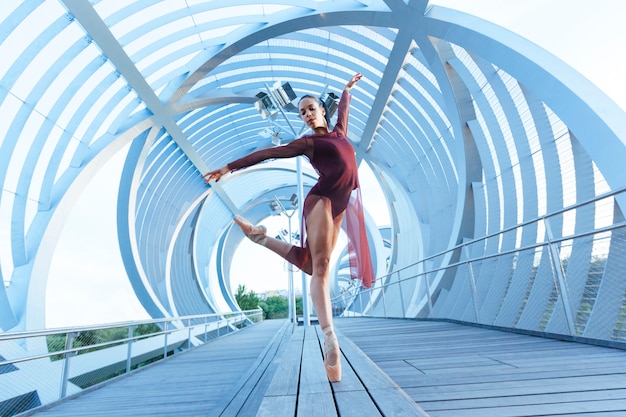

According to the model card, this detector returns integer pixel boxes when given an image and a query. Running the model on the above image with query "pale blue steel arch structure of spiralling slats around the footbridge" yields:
[0,0,626,337]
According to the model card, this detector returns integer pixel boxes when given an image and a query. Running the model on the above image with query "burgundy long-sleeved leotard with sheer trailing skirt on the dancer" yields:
[228,91,374,288]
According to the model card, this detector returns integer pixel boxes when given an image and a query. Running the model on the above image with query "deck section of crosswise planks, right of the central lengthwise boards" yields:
[336,319,626,417]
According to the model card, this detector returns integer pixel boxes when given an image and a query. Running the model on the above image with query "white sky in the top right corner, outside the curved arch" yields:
[431,0,626,110]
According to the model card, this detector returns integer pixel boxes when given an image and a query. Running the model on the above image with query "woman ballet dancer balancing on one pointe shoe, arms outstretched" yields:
[203,74,374,382]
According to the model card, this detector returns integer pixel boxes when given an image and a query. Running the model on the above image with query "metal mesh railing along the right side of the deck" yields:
[332,190,626,345]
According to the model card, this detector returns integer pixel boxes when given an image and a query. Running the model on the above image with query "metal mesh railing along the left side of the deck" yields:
[0,308,263,416]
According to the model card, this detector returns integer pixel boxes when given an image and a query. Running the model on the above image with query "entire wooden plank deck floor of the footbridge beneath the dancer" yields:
[23,318,626,417]
